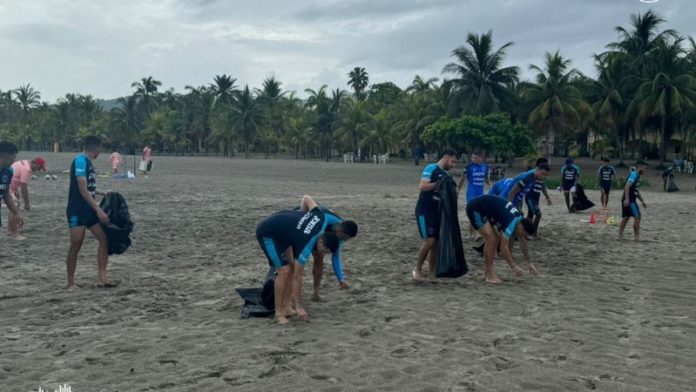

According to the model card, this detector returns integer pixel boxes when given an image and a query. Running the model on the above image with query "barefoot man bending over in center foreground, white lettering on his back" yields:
[256,196,339,325]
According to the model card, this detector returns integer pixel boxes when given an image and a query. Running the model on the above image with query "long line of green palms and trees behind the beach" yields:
[0,11,696,161]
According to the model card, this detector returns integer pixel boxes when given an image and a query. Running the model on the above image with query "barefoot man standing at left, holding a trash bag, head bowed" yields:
[65,136,117,290]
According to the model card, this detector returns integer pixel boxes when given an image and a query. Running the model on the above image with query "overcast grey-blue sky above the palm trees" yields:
[0,0,696,102]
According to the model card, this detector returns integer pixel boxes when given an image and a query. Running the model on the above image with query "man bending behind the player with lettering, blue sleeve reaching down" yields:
[300,196,358,301]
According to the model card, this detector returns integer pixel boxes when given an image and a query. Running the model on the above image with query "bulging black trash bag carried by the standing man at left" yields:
[99,192,134,255]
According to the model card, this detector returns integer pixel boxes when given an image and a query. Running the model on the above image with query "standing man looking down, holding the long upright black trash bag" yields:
[412,149,457,281]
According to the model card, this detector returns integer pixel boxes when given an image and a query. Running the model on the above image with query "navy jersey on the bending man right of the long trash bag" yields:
[466,195,522,238]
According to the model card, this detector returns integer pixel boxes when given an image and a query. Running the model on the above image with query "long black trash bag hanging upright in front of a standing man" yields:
[436,176,469,278]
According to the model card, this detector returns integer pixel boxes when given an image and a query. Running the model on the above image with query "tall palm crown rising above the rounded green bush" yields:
[442,30,519,114]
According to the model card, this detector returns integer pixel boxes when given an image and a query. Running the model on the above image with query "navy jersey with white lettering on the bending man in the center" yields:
[257,207,328,265]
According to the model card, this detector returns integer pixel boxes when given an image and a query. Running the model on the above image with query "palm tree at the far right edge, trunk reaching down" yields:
[629,38,696,166]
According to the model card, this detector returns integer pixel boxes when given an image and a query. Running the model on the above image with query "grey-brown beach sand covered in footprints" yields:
[0,154,696,392]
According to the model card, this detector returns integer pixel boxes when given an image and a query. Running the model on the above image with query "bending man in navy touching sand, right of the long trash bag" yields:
[466,195,537,284]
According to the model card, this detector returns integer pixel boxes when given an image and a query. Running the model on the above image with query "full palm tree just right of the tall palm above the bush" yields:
[521,51,592,156]
